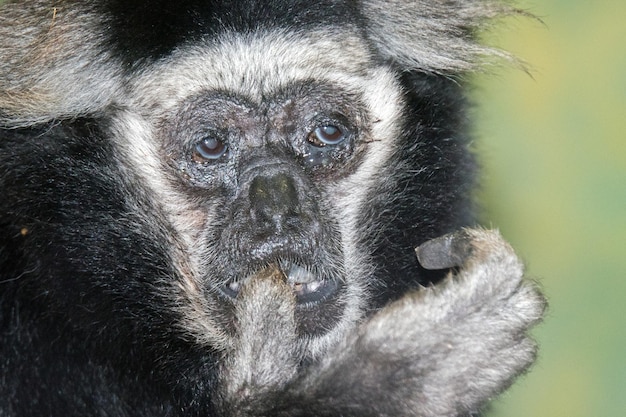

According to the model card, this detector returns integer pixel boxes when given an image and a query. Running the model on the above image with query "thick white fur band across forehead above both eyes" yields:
[133,30,371,114]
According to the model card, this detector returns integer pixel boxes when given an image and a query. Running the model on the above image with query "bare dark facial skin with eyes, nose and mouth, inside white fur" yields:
[167,86,358,335]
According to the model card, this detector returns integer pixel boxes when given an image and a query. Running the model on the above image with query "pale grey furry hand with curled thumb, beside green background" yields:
[282,229,545,417]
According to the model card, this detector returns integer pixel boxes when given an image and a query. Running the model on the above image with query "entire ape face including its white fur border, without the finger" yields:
[105,32,403,354]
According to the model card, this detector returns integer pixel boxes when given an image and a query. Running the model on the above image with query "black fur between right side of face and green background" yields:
[368,73,476,303]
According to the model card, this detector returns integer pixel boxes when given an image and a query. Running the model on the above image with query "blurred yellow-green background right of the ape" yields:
[474,0,626,417]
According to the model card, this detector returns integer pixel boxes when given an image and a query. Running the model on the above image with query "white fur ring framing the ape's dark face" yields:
[120,31,410,356]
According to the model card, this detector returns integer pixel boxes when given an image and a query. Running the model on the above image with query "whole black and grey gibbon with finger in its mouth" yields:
[0,0,545,417]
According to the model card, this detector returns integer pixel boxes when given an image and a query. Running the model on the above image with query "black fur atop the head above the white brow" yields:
[102,0,362,66]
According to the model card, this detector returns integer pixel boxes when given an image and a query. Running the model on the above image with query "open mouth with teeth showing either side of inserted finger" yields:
[222,260,337,304]
